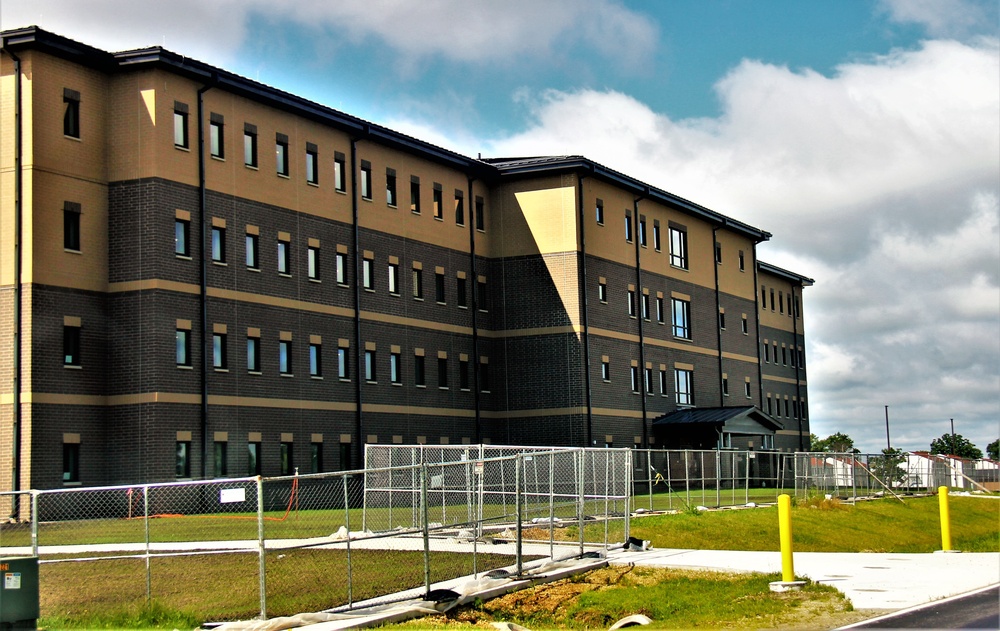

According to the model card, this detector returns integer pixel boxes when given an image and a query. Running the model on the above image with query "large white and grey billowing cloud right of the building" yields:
[480,39,1000,449]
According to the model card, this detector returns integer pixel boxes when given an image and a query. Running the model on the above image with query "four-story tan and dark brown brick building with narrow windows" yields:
[0,28,812,489]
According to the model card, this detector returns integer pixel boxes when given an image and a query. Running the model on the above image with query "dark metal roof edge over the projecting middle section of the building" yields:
[482,156,771,242]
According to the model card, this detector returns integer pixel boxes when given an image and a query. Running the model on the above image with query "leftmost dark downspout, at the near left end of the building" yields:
[3,39,23,508]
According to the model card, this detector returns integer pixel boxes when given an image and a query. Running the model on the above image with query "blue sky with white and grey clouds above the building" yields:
[0,0,1000,452]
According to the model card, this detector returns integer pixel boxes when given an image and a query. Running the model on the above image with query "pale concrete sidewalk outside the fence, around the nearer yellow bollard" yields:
[608,549,1000,610]
